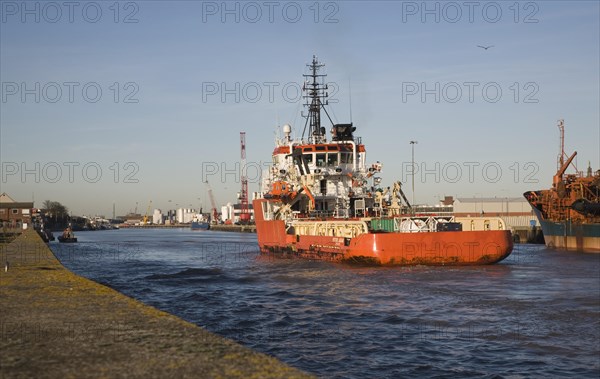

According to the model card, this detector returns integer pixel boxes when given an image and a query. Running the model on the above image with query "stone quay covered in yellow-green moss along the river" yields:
[0,231,311,378]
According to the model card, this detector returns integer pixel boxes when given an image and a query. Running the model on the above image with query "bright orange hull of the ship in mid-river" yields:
[255,200,513,266]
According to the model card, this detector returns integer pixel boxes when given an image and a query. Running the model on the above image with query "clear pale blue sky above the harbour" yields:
[0,1,600,215]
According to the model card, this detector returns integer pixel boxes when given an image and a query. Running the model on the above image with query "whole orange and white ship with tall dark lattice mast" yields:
[253,57,513,265]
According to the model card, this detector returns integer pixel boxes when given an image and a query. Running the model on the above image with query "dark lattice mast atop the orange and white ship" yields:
[302,55,329,143]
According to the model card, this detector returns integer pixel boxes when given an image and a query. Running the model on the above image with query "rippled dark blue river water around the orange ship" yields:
[50,229,600,378]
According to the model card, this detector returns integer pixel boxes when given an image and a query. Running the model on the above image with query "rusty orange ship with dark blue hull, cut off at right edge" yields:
[524,120,600,253]
